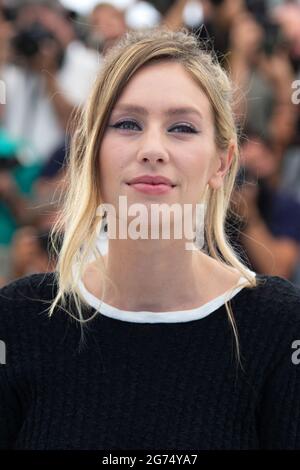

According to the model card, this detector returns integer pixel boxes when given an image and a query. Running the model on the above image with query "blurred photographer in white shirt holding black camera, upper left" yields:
[1,3,99,161]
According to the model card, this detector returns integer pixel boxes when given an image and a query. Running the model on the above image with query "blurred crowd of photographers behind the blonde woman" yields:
[0,0,300,287]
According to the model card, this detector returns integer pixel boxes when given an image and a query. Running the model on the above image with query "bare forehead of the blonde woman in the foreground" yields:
[115,61,212,118]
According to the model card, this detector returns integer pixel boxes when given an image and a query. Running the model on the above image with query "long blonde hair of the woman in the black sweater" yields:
[49,27,264,364]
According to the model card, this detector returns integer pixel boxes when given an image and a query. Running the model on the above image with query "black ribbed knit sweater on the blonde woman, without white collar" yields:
[0,273,300,450]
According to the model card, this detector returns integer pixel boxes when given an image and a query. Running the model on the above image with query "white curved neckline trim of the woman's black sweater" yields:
[78,269,256,323]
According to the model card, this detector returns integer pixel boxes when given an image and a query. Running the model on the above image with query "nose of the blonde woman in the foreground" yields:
[137,129,169,164]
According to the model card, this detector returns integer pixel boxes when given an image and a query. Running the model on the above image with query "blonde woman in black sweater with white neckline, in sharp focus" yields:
[0,29,300,449]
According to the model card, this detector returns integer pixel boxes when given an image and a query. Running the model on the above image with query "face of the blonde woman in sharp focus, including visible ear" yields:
[99,62,234,220]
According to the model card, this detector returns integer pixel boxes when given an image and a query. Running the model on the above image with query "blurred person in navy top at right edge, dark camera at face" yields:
[229,131,300,281]
